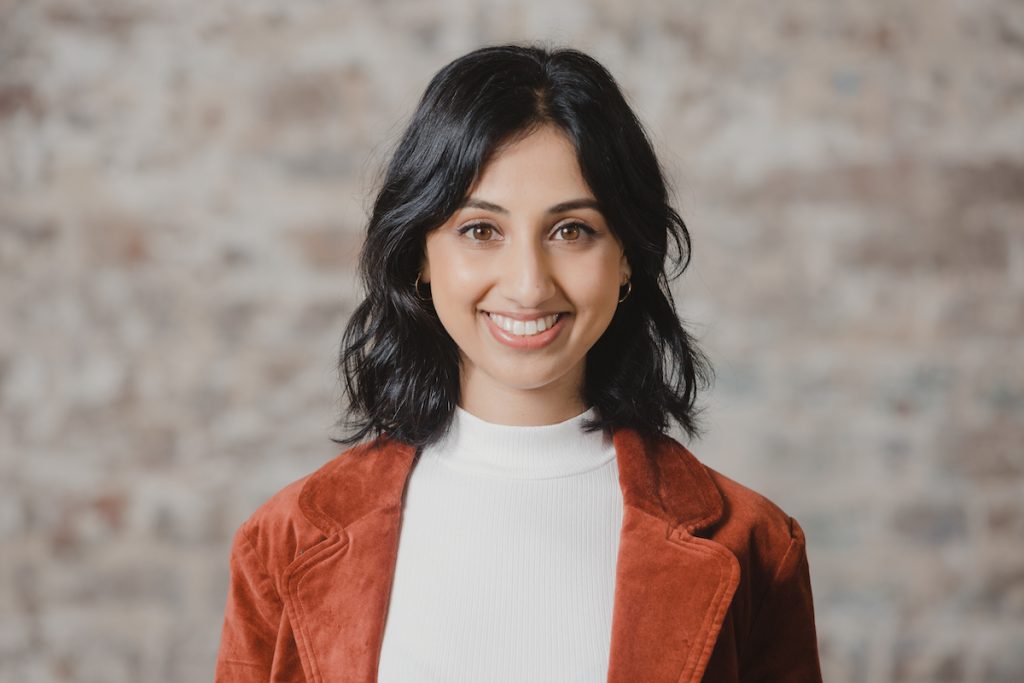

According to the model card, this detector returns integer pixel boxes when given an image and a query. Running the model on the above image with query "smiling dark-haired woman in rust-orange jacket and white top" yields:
[217,45,820,683]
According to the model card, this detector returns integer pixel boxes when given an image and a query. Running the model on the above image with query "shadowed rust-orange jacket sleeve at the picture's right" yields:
[740,517,821,683]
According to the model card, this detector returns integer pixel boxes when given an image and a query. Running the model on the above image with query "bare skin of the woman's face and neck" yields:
[421,126,630,425]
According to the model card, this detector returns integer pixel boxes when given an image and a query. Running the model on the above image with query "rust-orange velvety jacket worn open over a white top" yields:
[216,428,821,683]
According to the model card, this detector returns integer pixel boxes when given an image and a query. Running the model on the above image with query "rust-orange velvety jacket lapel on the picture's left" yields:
[283,438,417,683]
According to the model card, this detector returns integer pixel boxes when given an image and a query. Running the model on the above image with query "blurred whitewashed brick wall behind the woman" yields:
[0,0,1024,683]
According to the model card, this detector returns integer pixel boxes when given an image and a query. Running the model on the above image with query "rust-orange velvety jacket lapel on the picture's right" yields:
[608,429,739,683]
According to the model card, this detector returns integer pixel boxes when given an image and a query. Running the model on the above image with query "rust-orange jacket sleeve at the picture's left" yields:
[214,523,283,683]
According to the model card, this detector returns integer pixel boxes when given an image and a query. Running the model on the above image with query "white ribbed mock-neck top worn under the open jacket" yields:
[378,408,623,683]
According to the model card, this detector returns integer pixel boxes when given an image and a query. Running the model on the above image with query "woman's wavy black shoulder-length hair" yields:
[331,44,713,445]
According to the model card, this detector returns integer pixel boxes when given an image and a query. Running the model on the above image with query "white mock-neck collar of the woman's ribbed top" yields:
[424,405,615,479]
